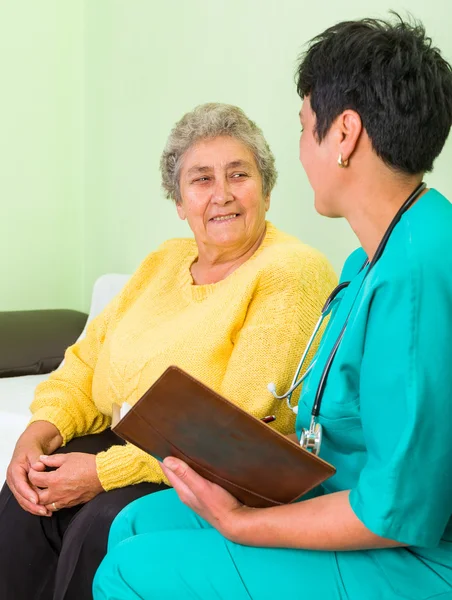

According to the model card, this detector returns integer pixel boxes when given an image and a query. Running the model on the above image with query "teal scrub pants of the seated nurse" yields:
[93,490,450,600]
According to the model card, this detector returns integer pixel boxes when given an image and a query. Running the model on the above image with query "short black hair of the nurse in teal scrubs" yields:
[296,13,452,175]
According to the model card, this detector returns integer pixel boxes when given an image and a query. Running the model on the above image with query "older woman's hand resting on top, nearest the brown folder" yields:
[28,452,104,511]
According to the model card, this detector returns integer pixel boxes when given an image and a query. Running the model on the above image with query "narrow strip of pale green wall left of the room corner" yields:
[0,0,84,310]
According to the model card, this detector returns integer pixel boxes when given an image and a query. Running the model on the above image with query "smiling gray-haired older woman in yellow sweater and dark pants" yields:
[0,104,335,600]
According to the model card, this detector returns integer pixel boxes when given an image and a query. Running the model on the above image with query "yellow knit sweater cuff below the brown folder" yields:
[96,444,169,492]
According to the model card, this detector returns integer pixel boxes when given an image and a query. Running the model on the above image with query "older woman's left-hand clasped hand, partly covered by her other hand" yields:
[6,441,51,517]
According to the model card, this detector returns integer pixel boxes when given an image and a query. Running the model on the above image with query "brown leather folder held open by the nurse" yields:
[113,367,335,508]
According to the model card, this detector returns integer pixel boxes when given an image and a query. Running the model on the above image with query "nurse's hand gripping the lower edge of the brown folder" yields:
[162,457,249,540]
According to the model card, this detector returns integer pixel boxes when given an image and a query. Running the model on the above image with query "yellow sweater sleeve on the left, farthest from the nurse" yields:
[30,251,165,445]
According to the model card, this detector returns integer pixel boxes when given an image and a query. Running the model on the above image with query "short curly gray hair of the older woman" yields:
[160,102,278,202]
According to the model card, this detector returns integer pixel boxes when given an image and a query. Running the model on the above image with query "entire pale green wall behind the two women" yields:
[0,0,452,310]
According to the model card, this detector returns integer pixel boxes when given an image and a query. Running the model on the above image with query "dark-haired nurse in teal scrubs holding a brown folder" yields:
[94,19,452,600]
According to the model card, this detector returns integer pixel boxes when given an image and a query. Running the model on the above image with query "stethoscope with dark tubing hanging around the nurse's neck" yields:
[267,182,427,454]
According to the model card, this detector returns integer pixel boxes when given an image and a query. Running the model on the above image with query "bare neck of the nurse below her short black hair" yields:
[343,165,425,261]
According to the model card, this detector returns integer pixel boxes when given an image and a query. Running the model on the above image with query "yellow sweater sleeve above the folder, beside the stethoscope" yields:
[220,249,337,433]
